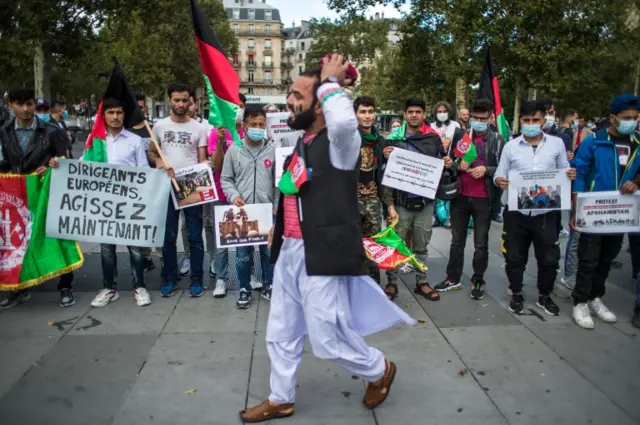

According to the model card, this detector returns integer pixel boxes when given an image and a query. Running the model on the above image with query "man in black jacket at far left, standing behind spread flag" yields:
[0,89,76,310]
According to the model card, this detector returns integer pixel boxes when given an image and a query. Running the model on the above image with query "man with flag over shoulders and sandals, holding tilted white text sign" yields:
[384,99,452,301]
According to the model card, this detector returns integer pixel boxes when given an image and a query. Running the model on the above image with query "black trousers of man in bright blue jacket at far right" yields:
[572,233,624,305]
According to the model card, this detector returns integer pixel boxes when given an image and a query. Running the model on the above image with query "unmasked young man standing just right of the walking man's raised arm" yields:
[353,96,398,285]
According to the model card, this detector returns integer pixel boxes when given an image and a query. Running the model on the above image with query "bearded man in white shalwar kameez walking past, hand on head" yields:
[240,55,415,422]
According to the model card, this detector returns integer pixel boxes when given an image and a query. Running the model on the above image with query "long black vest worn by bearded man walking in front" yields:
[271,129,366,276]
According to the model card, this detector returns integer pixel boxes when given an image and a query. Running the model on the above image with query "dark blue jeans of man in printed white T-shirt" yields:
[162,198,204,285]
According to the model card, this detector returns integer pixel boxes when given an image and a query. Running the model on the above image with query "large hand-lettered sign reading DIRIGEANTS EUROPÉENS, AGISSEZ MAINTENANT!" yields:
[47,159,170,247]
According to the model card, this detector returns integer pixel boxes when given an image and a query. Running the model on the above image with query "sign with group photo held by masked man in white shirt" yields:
[508,169,571,211]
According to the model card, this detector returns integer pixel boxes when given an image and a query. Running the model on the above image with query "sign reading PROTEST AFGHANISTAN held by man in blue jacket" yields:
[576,191,640,233]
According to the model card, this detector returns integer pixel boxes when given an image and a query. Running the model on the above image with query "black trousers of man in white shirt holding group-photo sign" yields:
[502,209,560,295]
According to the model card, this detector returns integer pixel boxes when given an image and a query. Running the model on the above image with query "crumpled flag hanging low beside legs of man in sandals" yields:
[362,225,427,271]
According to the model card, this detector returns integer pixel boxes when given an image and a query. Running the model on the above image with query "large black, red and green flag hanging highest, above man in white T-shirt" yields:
[191,0,242,147]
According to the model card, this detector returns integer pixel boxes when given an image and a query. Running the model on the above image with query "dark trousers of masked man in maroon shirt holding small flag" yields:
[447,195,491,282]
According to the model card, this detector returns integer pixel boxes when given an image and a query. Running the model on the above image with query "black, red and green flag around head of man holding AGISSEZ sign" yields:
[83,58,145,162]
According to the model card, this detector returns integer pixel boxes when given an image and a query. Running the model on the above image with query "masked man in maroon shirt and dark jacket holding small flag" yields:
[435,99,504,300]
